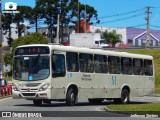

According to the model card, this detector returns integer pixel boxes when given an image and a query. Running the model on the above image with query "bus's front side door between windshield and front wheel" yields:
[51,54,66,99]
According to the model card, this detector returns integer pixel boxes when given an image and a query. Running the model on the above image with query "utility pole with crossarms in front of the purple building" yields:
[145,6,151,49]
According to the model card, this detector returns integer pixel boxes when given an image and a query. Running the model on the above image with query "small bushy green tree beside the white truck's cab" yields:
[102,30,122,47]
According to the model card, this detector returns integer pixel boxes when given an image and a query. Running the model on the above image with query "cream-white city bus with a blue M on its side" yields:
[12,44,154,106]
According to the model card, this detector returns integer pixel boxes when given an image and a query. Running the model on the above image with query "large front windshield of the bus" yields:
[13,55,50,81]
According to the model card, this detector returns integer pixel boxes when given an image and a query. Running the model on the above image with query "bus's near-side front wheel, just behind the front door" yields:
[66,88,77,106]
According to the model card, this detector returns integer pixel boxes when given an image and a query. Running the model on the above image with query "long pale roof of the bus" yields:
[17,44,153,59]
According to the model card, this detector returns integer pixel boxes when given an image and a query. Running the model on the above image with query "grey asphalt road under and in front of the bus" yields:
[0,96,160,120]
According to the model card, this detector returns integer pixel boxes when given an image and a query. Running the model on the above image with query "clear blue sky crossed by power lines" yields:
[2,0,160,30]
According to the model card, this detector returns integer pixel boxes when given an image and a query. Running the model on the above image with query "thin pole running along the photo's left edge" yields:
[0,0,3,80]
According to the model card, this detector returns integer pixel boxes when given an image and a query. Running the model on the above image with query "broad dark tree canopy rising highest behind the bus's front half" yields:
[35,0,98,42]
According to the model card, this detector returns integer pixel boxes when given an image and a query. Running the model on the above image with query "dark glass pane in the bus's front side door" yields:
[52,54,66,77]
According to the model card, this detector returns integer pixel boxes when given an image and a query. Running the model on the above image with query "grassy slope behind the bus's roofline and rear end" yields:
[120,49,160,93]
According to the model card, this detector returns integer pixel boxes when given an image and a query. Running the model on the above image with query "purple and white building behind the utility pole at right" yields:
[90,26,160,47]
